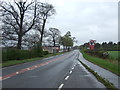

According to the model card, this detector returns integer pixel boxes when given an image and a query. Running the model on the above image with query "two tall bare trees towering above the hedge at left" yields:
[0,0,56,49]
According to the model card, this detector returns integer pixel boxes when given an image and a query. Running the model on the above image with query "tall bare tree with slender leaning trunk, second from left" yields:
[35,2,55,46]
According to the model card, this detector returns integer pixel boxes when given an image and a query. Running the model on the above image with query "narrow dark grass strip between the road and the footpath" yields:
[78,60,119,90]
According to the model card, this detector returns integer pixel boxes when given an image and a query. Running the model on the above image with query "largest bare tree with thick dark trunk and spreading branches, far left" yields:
[0,0,36,49]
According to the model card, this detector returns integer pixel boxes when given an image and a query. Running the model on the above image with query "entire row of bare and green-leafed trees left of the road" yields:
[0,0,75,53]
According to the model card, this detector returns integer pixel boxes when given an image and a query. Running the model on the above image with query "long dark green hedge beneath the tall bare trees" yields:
[2,48,44,62]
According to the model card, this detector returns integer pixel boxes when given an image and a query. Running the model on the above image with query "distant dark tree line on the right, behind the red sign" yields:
[80,41,120,51]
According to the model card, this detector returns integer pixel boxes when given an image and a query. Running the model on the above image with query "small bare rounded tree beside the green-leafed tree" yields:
[48,28,60,46]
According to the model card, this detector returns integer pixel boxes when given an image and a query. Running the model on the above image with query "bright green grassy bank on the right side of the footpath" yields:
[81,51,120,76]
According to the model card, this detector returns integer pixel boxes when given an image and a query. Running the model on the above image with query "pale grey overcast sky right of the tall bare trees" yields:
[43,0,118,45]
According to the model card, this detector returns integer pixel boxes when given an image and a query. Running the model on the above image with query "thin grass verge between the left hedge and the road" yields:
[0,52,63,67]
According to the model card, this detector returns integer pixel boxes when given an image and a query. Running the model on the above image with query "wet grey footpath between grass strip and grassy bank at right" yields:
[79,52,120,88]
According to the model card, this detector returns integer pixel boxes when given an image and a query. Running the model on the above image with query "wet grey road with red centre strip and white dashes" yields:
[2,50,105,90]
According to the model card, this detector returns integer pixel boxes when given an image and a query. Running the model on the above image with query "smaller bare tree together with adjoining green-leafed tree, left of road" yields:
[46,28,76,51]
